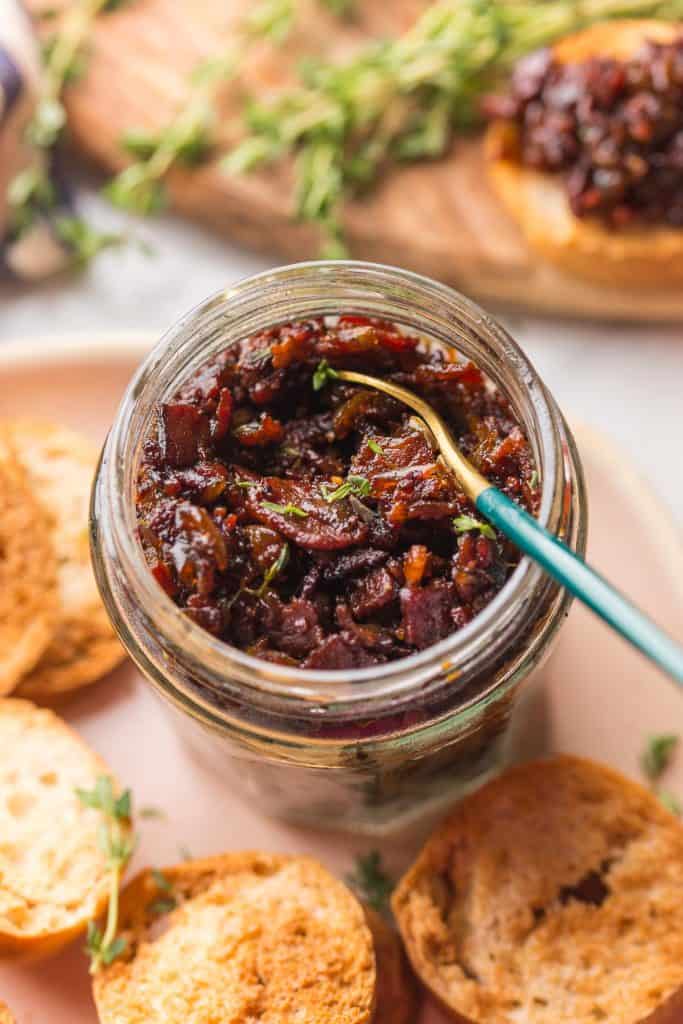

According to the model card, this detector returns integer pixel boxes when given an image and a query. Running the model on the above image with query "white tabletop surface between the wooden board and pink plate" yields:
[0,185,683,529]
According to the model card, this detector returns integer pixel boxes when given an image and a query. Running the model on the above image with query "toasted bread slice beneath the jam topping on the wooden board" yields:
[485,20,683,289]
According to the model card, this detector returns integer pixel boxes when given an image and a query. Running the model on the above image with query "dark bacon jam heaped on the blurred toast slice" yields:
[484,33,683,227]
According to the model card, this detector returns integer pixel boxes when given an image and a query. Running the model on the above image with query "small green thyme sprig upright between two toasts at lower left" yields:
[76,775,135,974]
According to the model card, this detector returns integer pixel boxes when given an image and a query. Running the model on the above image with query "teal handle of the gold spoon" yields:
[475,487,683,685]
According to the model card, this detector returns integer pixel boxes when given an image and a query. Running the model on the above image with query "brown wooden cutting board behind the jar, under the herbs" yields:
[29,0,683,321]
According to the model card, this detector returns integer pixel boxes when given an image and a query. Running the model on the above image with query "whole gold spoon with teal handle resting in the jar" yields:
[336,370,683,685]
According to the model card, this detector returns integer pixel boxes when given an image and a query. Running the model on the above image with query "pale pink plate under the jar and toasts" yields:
[0,337,683,1024]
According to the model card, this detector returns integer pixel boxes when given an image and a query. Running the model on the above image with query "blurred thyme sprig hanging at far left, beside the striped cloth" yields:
[7,0,122,260]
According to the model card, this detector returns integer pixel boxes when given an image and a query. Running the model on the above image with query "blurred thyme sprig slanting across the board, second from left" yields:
[104,0,349,215]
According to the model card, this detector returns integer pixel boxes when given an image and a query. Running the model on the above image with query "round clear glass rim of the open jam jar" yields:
[94,260,563,706]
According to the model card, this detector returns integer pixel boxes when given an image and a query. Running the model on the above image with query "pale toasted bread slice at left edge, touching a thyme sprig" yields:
[0,699,119,958]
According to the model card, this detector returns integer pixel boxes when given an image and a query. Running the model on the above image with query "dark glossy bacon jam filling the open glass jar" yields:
[137,315,540,670]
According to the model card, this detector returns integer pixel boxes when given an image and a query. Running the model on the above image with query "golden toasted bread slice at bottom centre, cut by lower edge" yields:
[94,853,376,1024]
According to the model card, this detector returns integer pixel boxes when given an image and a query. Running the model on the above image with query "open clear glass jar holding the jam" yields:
[91,261,587,835]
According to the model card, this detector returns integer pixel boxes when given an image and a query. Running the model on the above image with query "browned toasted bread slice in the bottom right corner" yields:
[393,757,683,1024]
